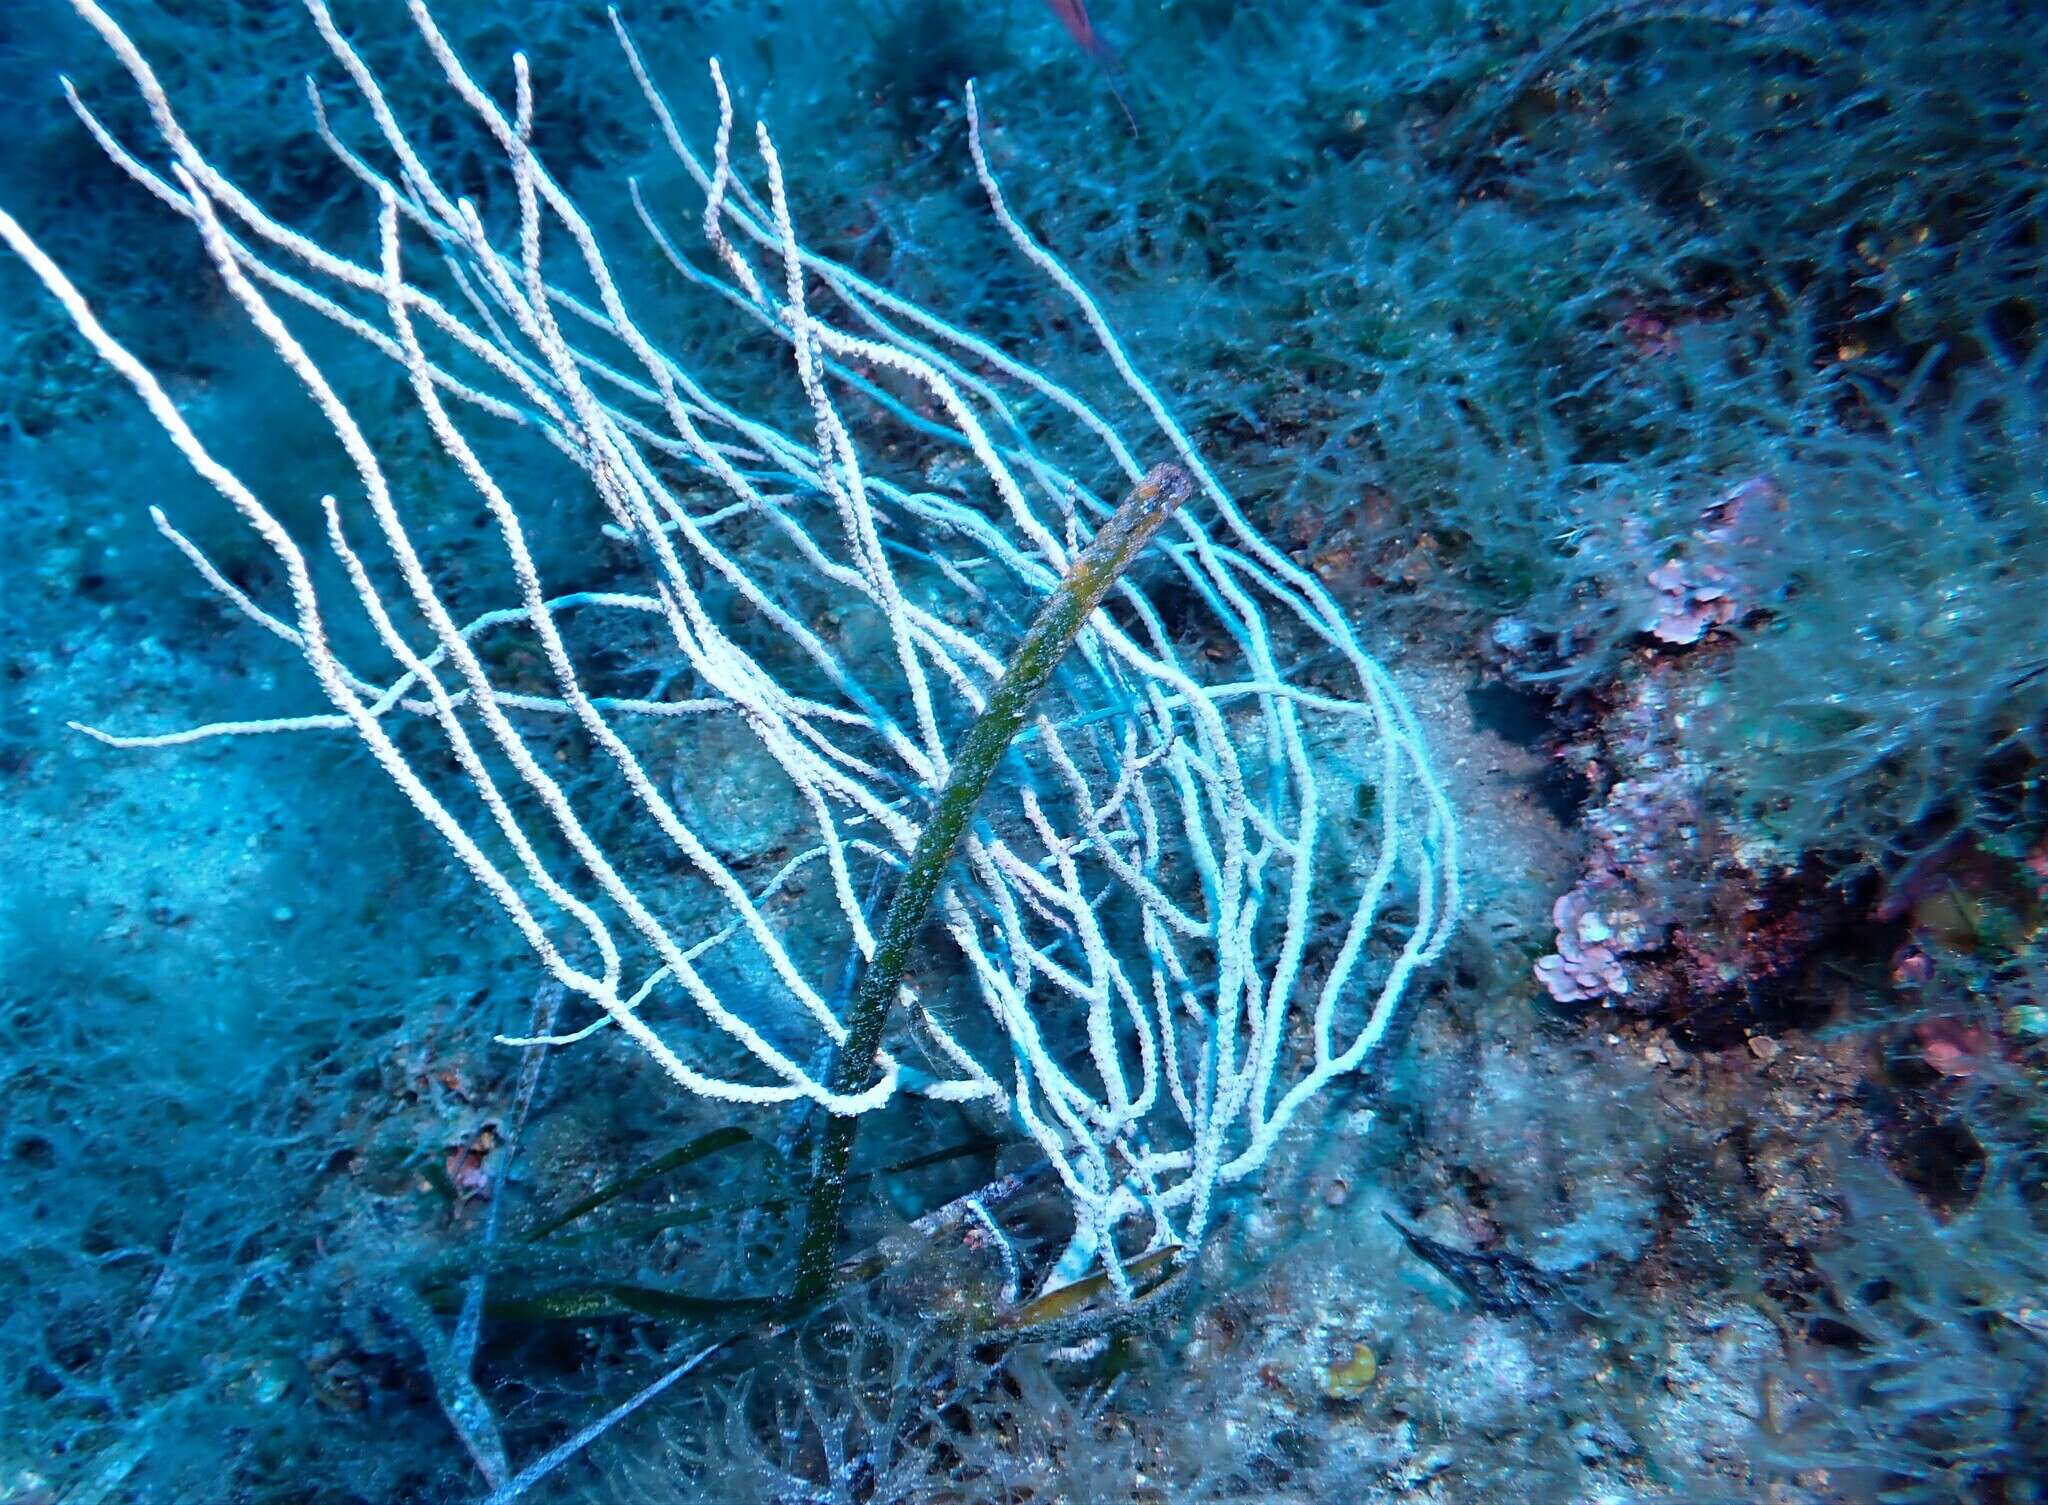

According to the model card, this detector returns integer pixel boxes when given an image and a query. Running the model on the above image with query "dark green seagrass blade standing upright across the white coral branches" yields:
[791,463,1194,1306]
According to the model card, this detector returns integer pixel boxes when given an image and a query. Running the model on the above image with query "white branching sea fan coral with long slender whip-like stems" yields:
[12,0,1458,1294]
